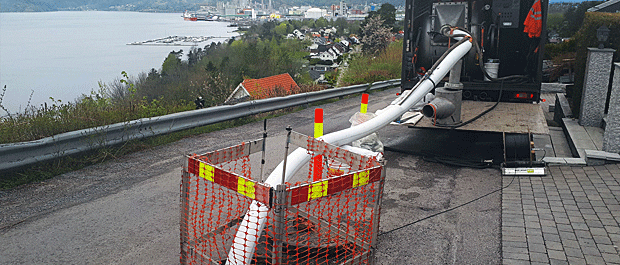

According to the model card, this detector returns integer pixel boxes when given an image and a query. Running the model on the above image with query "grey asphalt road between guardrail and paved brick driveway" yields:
[0,89,501,264]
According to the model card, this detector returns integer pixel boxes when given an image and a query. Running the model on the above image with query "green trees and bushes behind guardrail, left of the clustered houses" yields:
[0,38,318,143]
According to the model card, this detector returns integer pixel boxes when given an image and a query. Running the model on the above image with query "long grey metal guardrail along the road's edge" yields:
[0,79,400,172]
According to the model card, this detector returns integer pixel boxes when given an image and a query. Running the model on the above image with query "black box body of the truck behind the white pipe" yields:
[401,0,548,102]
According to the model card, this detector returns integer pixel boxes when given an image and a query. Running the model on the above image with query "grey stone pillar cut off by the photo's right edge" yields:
[602,63,620,153]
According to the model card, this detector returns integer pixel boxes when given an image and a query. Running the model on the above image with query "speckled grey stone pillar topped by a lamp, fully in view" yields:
[579,48,615,127]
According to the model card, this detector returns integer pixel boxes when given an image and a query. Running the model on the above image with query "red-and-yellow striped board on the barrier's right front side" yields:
[289,167,381,205]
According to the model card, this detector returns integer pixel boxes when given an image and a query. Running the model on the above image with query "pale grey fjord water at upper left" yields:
[0,11,238,112]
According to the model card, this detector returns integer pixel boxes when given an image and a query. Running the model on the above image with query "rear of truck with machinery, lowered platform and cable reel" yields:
[401,0,549,175]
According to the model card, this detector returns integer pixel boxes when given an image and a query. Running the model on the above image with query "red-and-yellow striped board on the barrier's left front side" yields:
[188,157,271,205]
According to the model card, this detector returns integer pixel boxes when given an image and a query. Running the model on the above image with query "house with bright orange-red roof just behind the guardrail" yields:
[224,73,299,104]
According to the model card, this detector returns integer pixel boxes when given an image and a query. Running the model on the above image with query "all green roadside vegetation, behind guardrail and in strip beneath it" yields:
[0,13,402,190]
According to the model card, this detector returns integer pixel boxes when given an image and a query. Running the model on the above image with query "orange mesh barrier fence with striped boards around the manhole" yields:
[180,132,385,264]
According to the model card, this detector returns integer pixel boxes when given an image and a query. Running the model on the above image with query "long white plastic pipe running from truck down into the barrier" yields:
[226,29,472,264]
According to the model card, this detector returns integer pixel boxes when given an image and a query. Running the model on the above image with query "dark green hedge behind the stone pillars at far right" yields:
[567,12,620,116]
